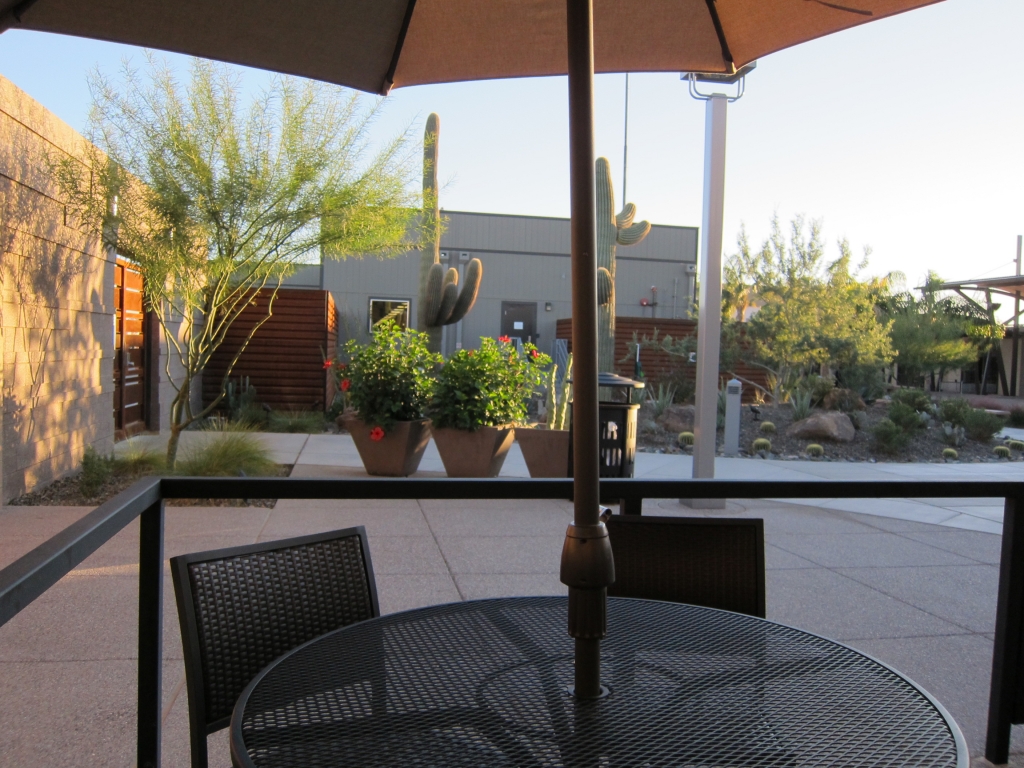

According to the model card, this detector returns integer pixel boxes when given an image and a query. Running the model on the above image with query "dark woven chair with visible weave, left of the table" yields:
[171,525,380,768]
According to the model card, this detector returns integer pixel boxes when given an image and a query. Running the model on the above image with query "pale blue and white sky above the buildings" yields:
[0,0,1024,301]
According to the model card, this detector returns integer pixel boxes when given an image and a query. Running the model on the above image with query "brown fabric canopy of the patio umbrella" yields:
[0,0,937,93]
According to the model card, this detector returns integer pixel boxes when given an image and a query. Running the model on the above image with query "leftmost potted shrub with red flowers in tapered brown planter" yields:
[335,321,441,477]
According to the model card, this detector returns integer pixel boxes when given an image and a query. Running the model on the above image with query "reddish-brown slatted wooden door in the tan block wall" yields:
[114,257,146,438]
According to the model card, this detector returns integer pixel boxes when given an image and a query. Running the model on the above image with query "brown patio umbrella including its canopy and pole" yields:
[0,0,938,698]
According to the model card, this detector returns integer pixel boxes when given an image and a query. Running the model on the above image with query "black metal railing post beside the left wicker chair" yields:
[136,499,164,768]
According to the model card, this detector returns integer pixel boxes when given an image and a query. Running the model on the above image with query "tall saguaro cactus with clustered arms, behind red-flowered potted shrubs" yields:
[417,113,483,352]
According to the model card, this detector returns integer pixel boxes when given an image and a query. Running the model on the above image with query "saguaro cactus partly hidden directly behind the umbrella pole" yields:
[596,158,650,372]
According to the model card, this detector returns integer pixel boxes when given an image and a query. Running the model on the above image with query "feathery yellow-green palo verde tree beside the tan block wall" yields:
[50,57,418,467]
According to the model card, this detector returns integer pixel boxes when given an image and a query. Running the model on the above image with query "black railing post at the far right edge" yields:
[985,497,1024,765]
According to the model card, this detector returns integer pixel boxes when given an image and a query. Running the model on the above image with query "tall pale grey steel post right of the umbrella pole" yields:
[684,94,728,508]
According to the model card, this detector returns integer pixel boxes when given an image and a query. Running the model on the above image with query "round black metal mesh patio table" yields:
[230,597,969,768]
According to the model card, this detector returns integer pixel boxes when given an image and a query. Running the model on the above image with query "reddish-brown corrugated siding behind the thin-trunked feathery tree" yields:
[203,288,338,411]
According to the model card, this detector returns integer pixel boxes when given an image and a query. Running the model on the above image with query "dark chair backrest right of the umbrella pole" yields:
[605,515,765,618]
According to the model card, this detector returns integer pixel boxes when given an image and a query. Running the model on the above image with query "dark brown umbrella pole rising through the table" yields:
[560,0,614,699]
